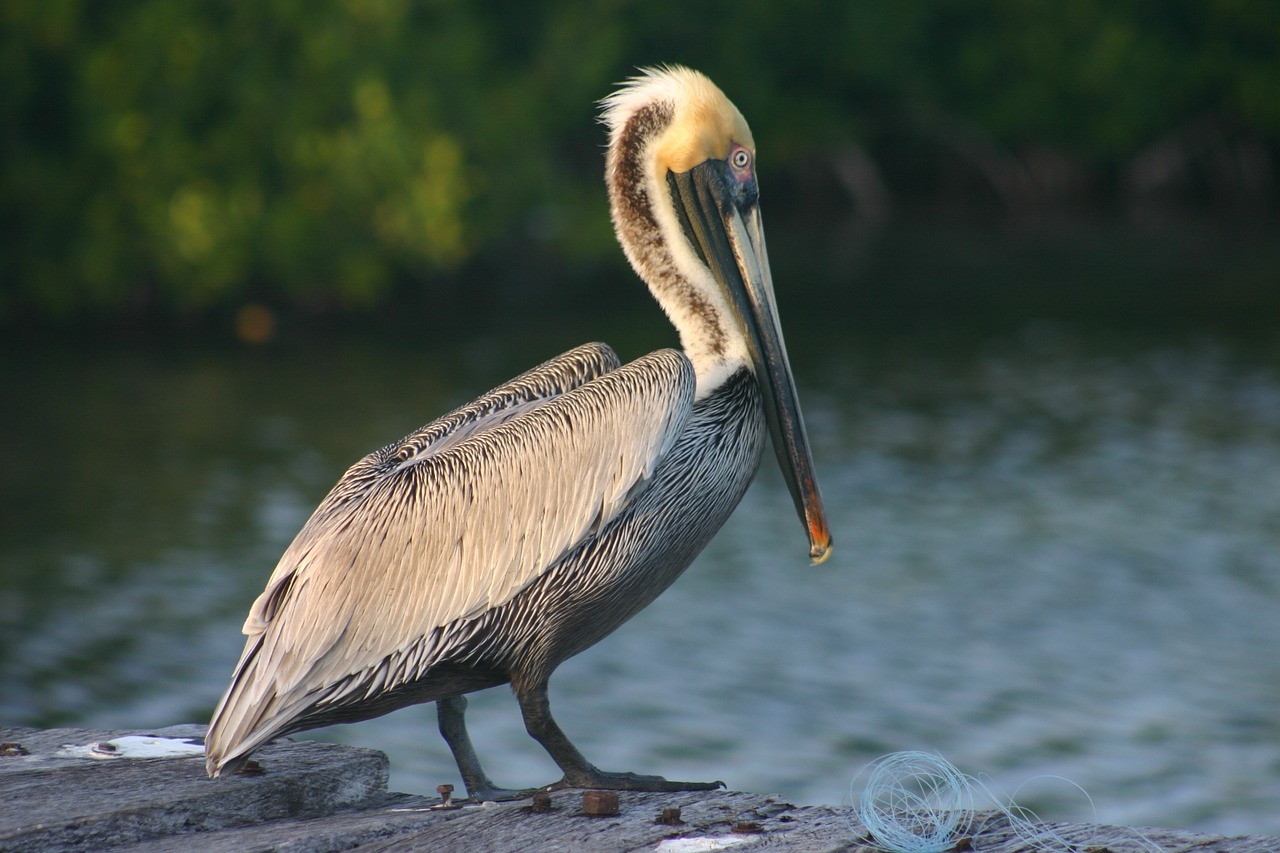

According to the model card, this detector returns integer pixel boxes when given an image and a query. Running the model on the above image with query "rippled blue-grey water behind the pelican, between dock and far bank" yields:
[0,320,1280,833]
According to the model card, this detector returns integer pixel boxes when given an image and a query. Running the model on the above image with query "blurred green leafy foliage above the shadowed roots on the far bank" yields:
[0,0,1280,321]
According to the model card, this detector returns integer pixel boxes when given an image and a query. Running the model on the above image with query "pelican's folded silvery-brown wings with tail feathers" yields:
[210,345,695,767]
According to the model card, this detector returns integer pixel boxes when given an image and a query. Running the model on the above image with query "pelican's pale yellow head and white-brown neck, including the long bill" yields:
[603,67,831,564]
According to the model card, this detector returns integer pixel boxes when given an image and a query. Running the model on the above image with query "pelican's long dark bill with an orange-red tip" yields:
[669,160,831,565]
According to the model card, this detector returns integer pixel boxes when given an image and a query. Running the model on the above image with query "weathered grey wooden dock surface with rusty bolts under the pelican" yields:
[0,726,1280,853]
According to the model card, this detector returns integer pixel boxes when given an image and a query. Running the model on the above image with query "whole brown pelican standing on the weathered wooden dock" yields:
[205,68,831,799]
